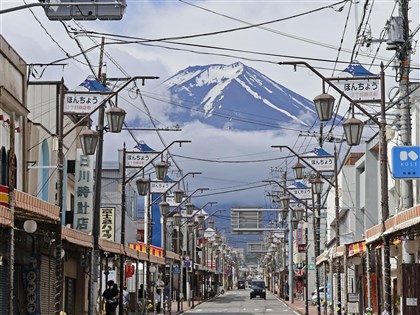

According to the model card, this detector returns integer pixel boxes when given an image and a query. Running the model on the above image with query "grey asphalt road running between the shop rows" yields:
[184,289,297,315]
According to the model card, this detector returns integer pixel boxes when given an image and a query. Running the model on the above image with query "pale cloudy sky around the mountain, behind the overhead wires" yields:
[0,0,420,228]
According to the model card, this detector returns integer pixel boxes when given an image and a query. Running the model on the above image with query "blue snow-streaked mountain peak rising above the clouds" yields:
[161,62,326,131]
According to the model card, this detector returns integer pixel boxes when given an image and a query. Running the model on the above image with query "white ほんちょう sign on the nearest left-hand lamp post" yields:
[64,92,109,114]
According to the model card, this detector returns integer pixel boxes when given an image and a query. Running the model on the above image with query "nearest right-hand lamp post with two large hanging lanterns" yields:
[279,61,392,314]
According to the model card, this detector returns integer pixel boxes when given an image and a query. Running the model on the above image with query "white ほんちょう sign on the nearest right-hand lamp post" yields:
[331,78,381,102]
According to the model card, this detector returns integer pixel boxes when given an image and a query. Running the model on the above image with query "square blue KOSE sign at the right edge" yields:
[392,146,420,179]
